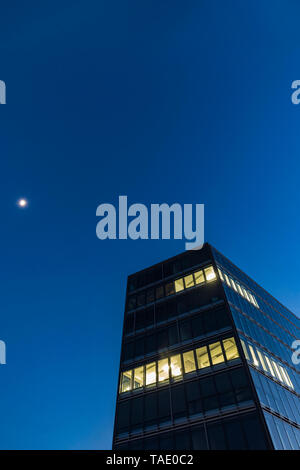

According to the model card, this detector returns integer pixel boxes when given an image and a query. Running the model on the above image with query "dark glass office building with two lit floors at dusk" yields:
[113,244,300,450]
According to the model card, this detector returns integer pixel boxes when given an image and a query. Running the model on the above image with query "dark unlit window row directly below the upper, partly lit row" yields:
[124,284,222,335]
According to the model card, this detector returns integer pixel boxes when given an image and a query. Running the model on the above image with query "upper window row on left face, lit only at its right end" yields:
[127,266,216,310]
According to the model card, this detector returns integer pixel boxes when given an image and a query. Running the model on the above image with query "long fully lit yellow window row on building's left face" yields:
[120,337,239,393]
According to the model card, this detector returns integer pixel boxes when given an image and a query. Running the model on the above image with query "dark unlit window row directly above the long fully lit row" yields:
[122,309,231,362]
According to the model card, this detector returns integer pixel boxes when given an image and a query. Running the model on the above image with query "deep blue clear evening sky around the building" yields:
[0,0,300,449]
